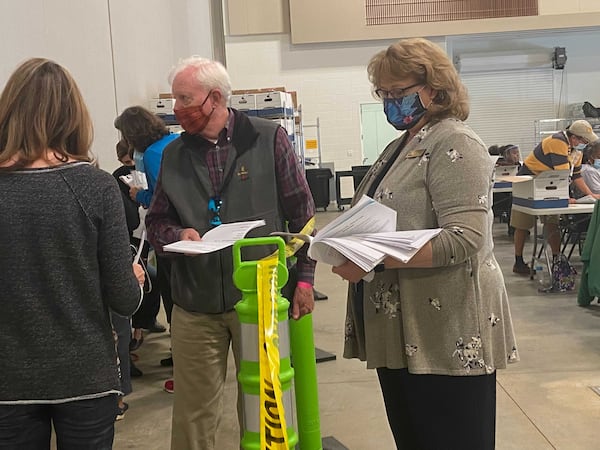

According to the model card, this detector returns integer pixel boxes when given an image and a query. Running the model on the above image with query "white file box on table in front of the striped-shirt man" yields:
[511,170,569,208]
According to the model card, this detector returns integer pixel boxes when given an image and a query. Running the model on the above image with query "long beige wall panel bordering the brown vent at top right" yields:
[289,0,600,44]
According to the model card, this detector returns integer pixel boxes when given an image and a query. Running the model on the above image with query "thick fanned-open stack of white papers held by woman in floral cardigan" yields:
[273,196,441,272]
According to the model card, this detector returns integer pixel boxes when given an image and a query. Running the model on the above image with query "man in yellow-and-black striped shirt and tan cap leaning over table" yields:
[510,120,600,275]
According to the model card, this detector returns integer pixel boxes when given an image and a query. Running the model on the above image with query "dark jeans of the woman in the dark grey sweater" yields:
[0,395,117,450]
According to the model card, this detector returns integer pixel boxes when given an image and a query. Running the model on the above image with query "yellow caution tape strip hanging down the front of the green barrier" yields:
[256,256,289,450]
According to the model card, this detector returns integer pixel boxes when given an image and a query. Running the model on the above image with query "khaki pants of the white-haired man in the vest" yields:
[171,305,242,450]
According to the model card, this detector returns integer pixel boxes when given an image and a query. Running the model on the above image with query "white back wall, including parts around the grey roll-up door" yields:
[226,28,600,170]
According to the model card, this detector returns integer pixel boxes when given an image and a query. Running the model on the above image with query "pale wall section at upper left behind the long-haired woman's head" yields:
[0,0,117,169]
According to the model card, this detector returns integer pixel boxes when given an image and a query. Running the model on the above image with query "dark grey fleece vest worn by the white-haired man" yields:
[161,110,285,313]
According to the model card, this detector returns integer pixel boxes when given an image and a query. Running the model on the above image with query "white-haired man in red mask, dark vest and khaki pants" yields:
[146,57,315,450]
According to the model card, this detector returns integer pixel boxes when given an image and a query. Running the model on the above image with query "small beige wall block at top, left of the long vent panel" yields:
[227,0,289,36]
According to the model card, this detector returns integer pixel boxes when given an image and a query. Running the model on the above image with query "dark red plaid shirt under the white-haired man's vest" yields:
[148,111,315,284]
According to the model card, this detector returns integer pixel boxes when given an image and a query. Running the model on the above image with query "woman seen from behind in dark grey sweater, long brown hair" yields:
[0,58,143,449]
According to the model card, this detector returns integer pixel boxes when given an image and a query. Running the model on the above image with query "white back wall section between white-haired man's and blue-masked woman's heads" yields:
[226,35,408,170]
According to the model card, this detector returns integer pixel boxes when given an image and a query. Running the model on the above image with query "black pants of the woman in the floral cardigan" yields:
[377,368,496,450]
